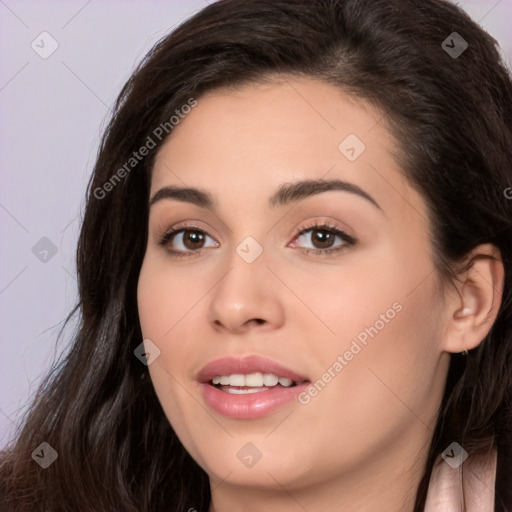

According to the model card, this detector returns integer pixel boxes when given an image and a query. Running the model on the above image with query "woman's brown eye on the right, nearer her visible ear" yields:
[292,222,356,254]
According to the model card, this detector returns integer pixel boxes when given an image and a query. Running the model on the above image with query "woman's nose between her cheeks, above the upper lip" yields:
[209,254,284,334]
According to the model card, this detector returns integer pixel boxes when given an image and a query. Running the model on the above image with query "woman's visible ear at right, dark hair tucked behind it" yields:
[443,244,505,352]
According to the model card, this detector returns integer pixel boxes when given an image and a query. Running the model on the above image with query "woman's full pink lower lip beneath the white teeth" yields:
[201,382,309,420]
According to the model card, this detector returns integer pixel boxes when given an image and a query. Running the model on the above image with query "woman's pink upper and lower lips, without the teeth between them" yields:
[197,356,309,419]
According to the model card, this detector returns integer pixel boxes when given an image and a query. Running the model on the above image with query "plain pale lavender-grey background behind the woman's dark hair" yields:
[0,0,512,447]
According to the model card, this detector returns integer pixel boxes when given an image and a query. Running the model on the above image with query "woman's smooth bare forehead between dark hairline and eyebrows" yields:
[151,77,421,220]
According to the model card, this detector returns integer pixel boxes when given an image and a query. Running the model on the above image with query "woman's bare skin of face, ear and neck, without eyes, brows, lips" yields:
[138,77,503,512]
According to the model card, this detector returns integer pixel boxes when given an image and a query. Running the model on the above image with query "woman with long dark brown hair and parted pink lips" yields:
[0,0,512,512]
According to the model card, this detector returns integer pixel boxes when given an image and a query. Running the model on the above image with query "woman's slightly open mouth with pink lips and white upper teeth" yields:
[197,356,311,419]
